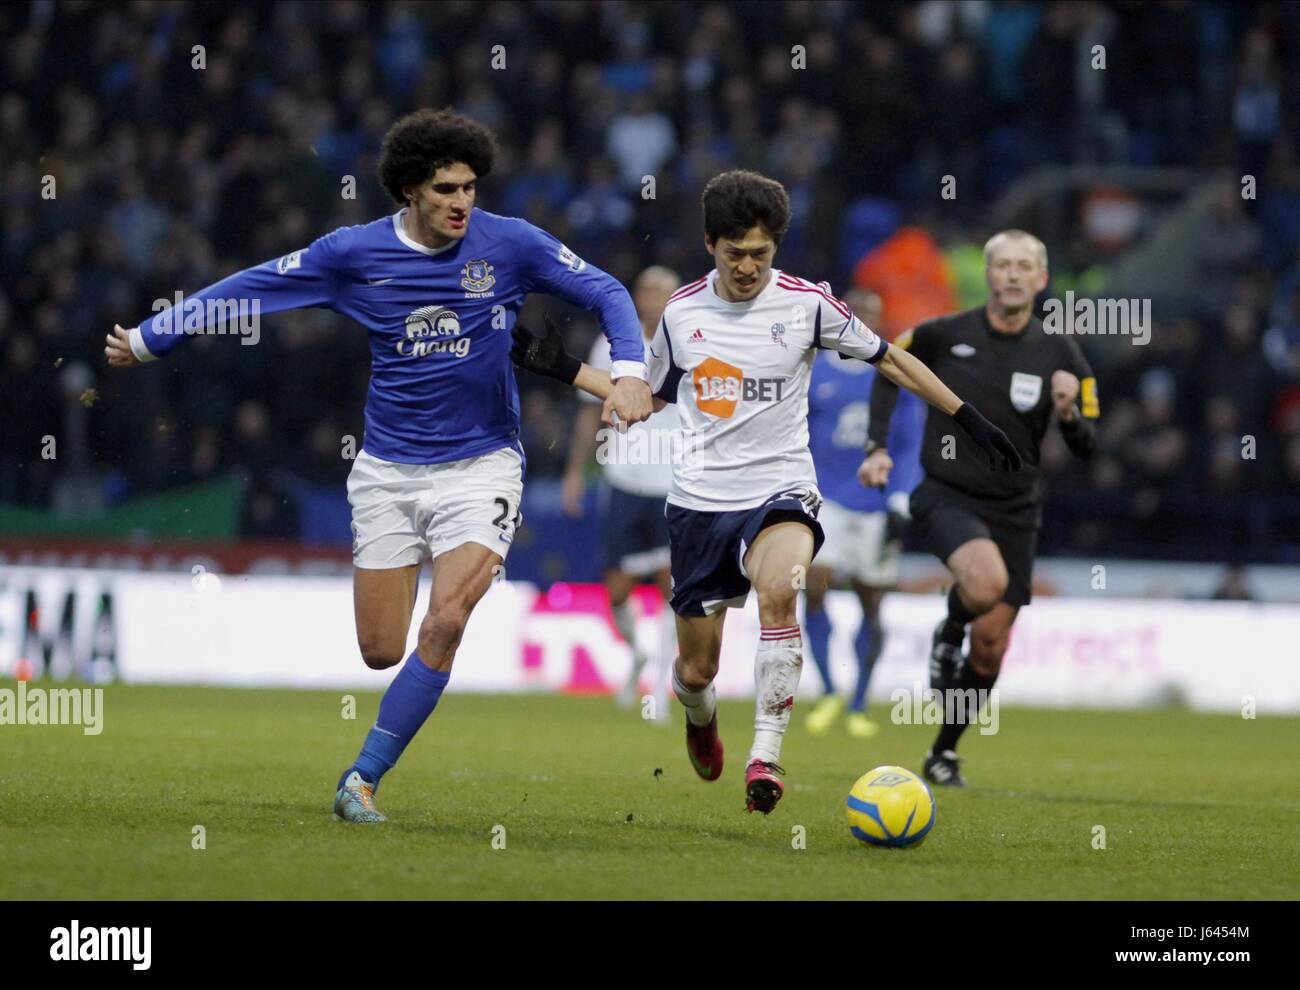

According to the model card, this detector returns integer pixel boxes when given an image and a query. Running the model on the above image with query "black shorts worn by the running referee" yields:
[910,478,1039,608]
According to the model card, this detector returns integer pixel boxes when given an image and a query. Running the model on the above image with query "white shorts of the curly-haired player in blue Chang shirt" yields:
[347,447,524,569]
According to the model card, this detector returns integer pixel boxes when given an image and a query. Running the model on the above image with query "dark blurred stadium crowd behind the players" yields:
[0,1,1300,582]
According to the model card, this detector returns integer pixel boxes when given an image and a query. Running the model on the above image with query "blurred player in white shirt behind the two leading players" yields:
[563,265,681,722]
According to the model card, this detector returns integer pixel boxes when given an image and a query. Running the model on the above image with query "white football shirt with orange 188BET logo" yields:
[647,268,888,512]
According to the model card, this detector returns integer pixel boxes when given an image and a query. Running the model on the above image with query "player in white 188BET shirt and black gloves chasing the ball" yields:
[511,170,1021,815]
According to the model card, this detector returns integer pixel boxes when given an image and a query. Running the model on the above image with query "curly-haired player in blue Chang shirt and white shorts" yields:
[105,110,651,822]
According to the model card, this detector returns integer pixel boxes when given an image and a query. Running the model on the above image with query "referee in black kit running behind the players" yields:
[859,230,1099,787]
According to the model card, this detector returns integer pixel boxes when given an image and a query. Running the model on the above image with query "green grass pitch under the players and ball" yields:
[0,681,1300,899]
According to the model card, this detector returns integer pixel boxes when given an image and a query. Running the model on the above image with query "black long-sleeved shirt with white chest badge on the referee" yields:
[870,307,1099,526]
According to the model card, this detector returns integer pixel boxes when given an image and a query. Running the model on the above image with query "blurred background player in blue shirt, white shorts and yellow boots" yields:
[803,288,926,738]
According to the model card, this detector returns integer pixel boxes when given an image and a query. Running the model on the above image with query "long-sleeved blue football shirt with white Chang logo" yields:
[131,208,645,464]
